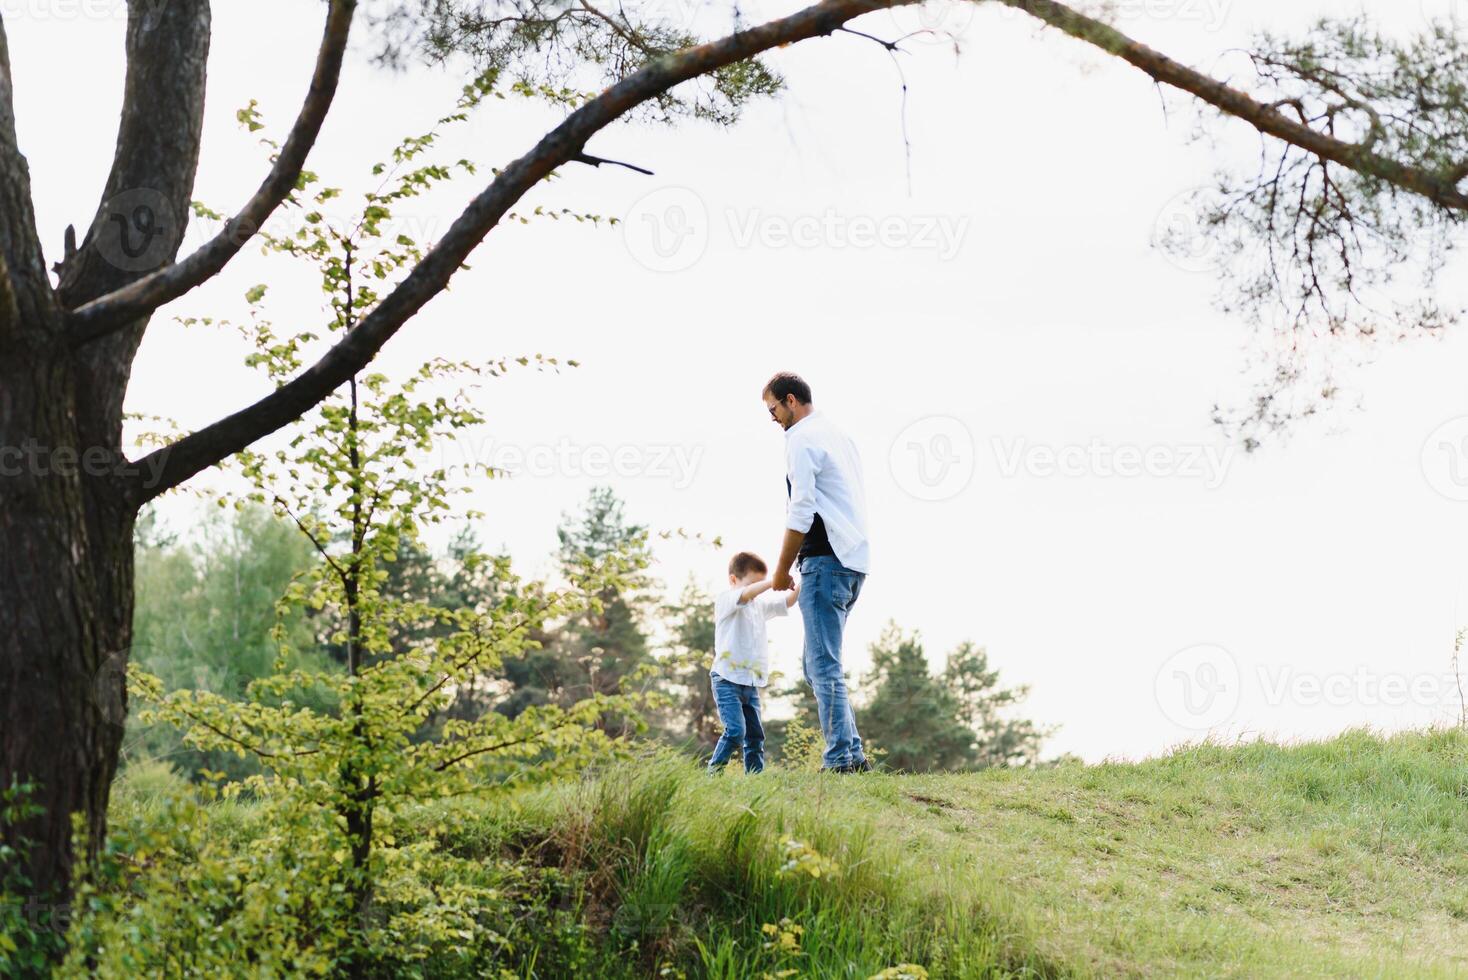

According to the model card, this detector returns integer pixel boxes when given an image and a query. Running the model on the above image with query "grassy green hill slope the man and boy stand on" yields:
[108,731,1468,980]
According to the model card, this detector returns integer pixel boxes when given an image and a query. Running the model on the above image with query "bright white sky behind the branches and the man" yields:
[11,0,1468,760]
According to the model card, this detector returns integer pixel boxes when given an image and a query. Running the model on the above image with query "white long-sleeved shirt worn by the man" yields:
[785,411,872,572]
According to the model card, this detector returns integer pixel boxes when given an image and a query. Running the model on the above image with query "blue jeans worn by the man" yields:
[800,555,866,769]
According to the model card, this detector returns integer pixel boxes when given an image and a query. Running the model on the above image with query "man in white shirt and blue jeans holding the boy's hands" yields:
[763,371,872,773]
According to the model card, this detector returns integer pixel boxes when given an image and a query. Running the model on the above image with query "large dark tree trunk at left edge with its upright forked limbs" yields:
[0,0,210,933]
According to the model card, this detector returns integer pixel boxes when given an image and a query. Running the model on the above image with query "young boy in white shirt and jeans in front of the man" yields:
[709,552,800,773]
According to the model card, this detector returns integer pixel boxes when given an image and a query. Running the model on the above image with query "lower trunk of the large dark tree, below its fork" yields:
[0,344,132,927]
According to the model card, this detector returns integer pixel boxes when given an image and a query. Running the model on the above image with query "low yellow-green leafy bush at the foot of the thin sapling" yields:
[65,794,607,980]
